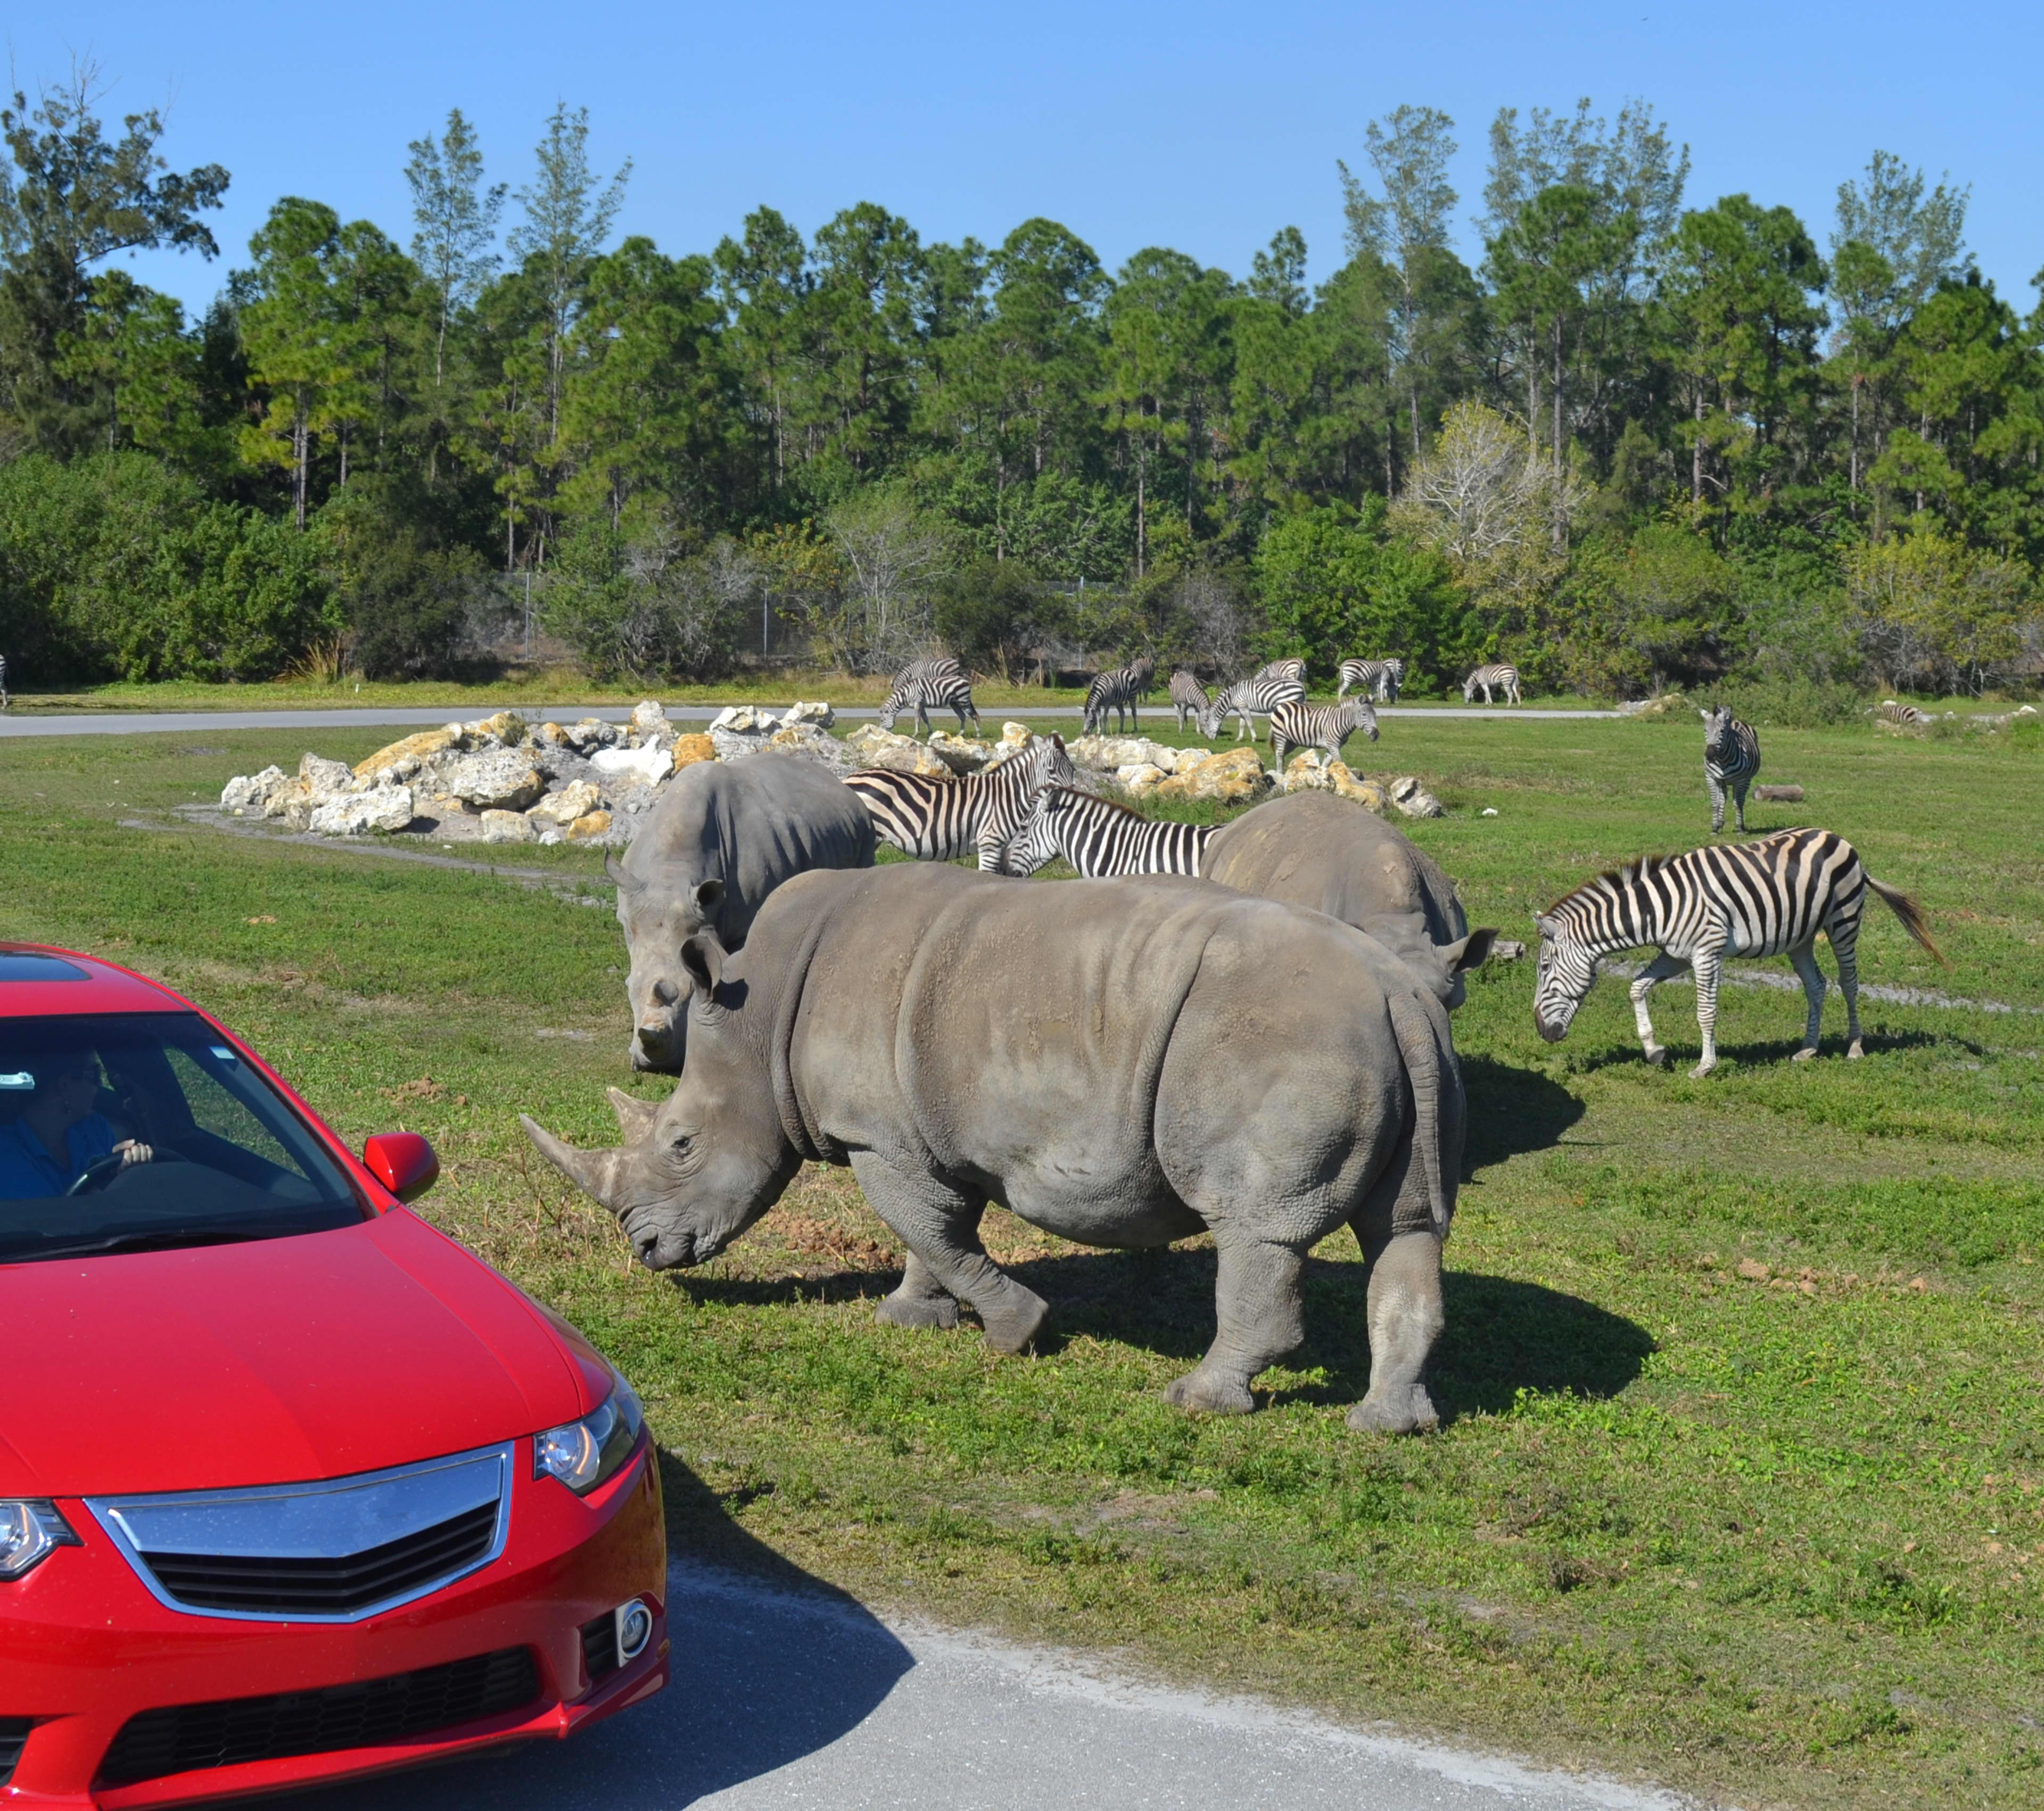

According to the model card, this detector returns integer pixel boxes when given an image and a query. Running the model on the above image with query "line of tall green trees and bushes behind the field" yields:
[0,70,2044,695]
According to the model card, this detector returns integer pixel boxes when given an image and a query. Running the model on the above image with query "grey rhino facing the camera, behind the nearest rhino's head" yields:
[609,754,873,1071]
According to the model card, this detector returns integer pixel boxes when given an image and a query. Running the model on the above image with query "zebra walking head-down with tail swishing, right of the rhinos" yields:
[1533,830,1944,1077]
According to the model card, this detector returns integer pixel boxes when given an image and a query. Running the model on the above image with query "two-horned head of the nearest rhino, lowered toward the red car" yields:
[519,930,801,1269]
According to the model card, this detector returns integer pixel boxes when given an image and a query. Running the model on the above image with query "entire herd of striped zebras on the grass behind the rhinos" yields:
[846,660,1944,1077]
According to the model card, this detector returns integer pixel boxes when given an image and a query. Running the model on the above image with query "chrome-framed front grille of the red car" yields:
[88,1445,511,1623]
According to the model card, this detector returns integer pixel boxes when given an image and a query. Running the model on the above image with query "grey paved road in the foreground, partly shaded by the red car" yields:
[299,1570,1680,1811]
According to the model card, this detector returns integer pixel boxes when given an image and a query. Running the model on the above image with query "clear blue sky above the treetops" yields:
[6,0,2044,309]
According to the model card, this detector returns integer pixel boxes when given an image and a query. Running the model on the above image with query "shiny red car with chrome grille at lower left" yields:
[0,944,669,1807]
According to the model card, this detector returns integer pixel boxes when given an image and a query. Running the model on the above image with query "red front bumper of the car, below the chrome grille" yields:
[0,1437,669,1811]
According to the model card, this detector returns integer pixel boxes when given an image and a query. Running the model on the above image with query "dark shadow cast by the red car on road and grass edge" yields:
[296,1451,916,1811]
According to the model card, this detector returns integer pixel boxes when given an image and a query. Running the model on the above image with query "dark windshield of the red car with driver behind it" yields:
[0,1012,370,1263]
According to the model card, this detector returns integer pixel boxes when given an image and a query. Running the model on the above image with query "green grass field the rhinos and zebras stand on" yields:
[0,717,2044,1807]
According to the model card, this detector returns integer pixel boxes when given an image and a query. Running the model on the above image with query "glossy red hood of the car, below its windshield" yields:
[0,1210,607,1496]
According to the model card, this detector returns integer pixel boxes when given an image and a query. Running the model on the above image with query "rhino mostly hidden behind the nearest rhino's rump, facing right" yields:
[1200,791,1496,1012]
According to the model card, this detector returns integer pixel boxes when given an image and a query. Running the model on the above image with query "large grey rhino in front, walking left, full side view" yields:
[523,863,1463,1433]
